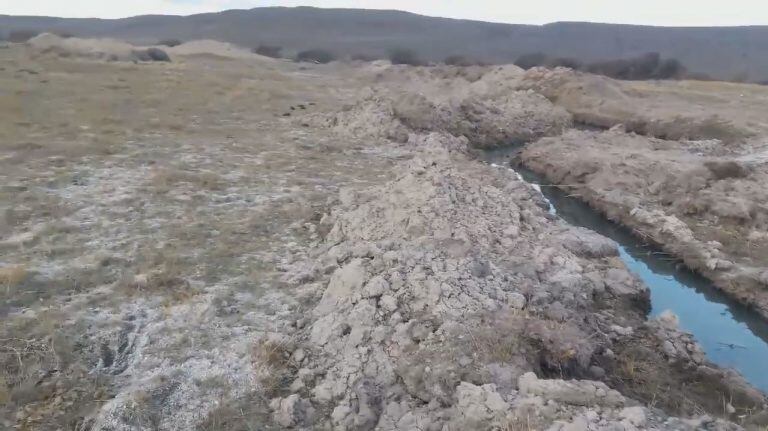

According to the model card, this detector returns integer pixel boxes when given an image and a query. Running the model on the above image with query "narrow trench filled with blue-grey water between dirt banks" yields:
[482,146,768,393]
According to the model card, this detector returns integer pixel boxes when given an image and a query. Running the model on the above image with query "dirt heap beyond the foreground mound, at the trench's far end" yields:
[316,66,571,148]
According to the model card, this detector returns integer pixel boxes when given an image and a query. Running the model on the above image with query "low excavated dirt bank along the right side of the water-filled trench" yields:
[522,130,768,318]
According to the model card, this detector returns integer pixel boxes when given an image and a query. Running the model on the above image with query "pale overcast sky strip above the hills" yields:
[0,0,768,26]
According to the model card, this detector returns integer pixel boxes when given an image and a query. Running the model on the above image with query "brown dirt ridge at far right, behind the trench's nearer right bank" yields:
[518,68,768,145]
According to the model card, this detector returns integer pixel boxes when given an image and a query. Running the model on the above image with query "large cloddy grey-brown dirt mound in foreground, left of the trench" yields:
[250,134,763,430]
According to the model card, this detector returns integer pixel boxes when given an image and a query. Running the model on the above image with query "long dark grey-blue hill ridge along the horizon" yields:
[0,7,768,81]
